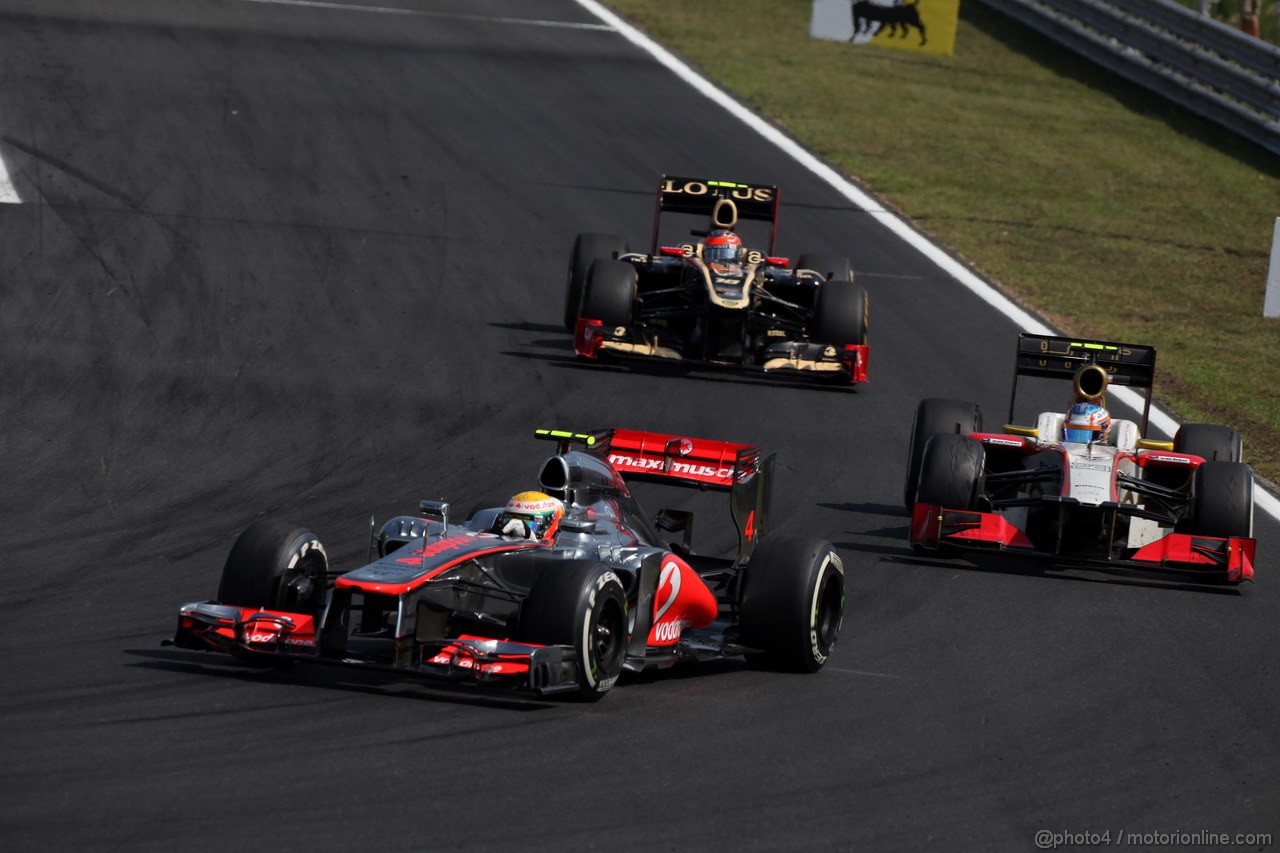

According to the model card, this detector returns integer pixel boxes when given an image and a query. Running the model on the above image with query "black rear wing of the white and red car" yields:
[1009,332,1156,435]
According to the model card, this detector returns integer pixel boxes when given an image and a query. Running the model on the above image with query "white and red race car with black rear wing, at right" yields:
[905,334,1256,583]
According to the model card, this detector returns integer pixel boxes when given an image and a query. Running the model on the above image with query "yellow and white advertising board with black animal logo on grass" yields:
[809,0,960,56]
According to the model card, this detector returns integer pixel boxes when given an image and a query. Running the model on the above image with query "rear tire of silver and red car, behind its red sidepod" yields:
[740,535,845,672]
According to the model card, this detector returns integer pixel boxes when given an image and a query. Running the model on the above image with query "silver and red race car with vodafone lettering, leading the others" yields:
[172,429,845,699]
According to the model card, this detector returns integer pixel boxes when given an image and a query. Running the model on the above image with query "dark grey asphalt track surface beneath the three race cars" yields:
[0,0,1280,850]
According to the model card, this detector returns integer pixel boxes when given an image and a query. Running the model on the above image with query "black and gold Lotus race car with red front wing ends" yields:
[564,175,870,384]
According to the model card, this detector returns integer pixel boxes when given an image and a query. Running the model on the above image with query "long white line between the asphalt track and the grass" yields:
[575,0,1280,521]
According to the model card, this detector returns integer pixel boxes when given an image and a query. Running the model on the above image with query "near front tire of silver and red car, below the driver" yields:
[520,560,627,702]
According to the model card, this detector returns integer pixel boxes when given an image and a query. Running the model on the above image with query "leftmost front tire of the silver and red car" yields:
[218,519,329,616]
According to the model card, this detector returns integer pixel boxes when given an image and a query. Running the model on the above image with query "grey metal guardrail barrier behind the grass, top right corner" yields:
[983,0,1280,154]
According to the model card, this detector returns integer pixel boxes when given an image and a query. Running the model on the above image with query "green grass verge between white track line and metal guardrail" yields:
[609,0,1280,482]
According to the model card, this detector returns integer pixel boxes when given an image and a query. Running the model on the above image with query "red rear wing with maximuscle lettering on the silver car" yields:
[535,429,774,562]
